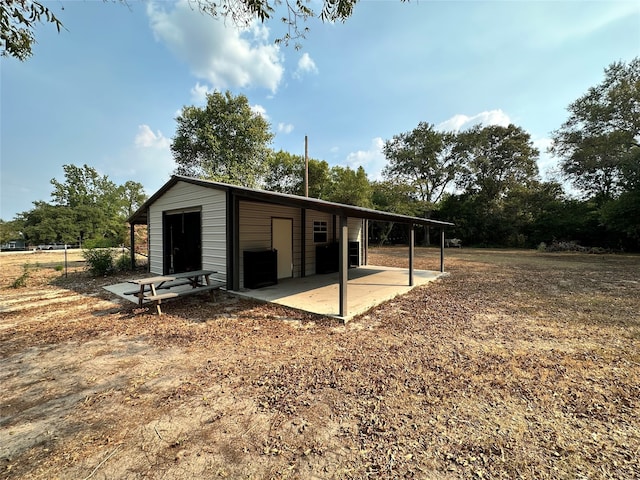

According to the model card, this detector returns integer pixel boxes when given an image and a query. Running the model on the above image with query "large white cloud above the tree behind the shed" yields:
[147,0,284,94]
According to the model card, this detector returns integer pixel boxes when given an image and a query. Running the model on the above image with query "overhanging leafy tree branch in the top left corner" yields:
[0,0,62,61]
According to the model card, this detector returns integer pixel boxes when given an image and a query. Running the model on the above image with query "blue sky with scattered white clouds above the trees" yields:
[0,0,640,220]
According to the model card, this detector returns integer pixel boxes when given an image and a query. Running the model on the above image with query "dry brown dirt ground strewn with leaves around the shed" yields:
[0,248,640,479]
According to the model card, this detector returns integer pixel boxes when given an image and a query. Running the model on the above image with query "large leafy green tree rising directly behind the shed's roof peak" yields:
[171,91,273,187]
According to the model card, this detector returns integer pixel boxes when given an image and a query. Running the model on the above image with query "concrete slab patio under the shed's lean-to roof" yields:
[230,265,446,321]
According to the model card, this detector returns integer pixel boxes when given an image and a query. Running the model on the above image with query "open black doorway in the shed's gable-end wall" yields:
[163,211,202,275]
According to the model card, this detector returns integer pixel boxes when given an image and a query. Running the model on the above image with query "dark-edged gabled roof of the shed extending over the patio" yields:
[128,175,453,227]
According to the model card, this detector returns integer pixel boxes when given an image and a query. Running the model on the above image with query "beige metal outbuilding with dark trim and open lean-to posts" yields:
[128,175,453,317]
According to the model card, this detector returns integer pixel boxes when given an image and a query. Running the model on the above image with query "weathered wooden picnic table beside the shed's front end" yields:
[125,270,224,315]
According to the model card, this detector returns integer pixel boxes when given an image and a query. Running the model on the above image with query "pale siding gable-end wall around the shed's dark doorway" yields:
[149,182,227,278]
